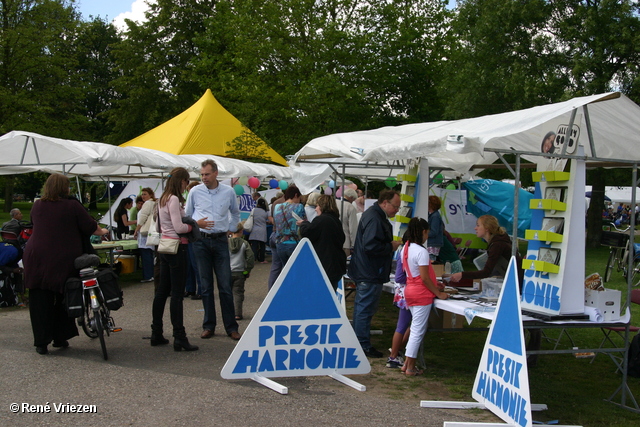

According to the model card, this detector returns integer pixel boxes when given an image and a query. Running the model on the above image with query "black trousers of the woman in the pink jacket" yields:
[151,244,187,339]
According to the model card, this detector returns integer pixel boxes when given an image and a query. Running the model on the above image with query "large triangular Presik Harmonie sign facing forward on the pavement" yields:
[220,239,371,379]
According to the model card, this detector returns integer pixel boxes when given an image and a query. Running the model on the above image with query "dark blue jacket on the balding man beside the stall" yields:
[349,203,393,283]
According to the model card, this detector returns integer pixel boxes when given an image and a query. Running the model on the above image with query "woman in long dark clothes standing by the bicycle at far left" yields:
[23,174,107,354]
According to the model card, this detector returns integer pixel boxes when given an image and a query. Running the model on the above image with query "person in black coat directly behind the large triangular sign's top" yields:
[298,195,347,290]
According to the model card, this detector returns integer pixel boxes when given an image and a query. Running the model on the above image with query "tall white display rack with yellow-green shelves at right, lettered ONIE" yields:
[522,150,586,316]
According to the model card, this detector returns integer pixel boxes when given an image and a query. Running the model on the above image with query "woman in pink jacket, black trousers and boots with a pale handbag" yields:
[151,167,206,351]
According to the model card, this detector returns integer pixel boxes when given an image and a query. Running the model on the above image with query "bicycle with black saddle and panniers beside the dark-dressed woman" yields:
[75,254,122,360]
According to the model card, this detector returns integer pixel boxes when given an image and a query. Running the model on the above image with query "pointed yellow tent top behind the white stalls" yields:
[120,89,287,166]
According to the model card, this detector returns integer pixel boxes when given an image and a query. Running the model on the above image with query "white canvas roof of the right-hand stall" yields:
[291,93,640,194]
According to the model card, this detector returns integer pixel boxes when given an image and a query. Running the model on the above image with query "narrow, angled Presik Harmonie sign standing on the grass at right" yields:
[473,257,533,427]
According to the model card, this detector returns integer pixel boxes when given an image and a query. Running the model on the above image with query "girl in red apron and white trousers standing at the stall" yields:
[401,218,449,376]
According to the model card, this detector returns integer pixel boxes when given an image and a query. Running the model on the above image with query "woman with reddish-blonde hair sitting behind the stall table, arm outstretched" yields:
[451,215,524,287]
